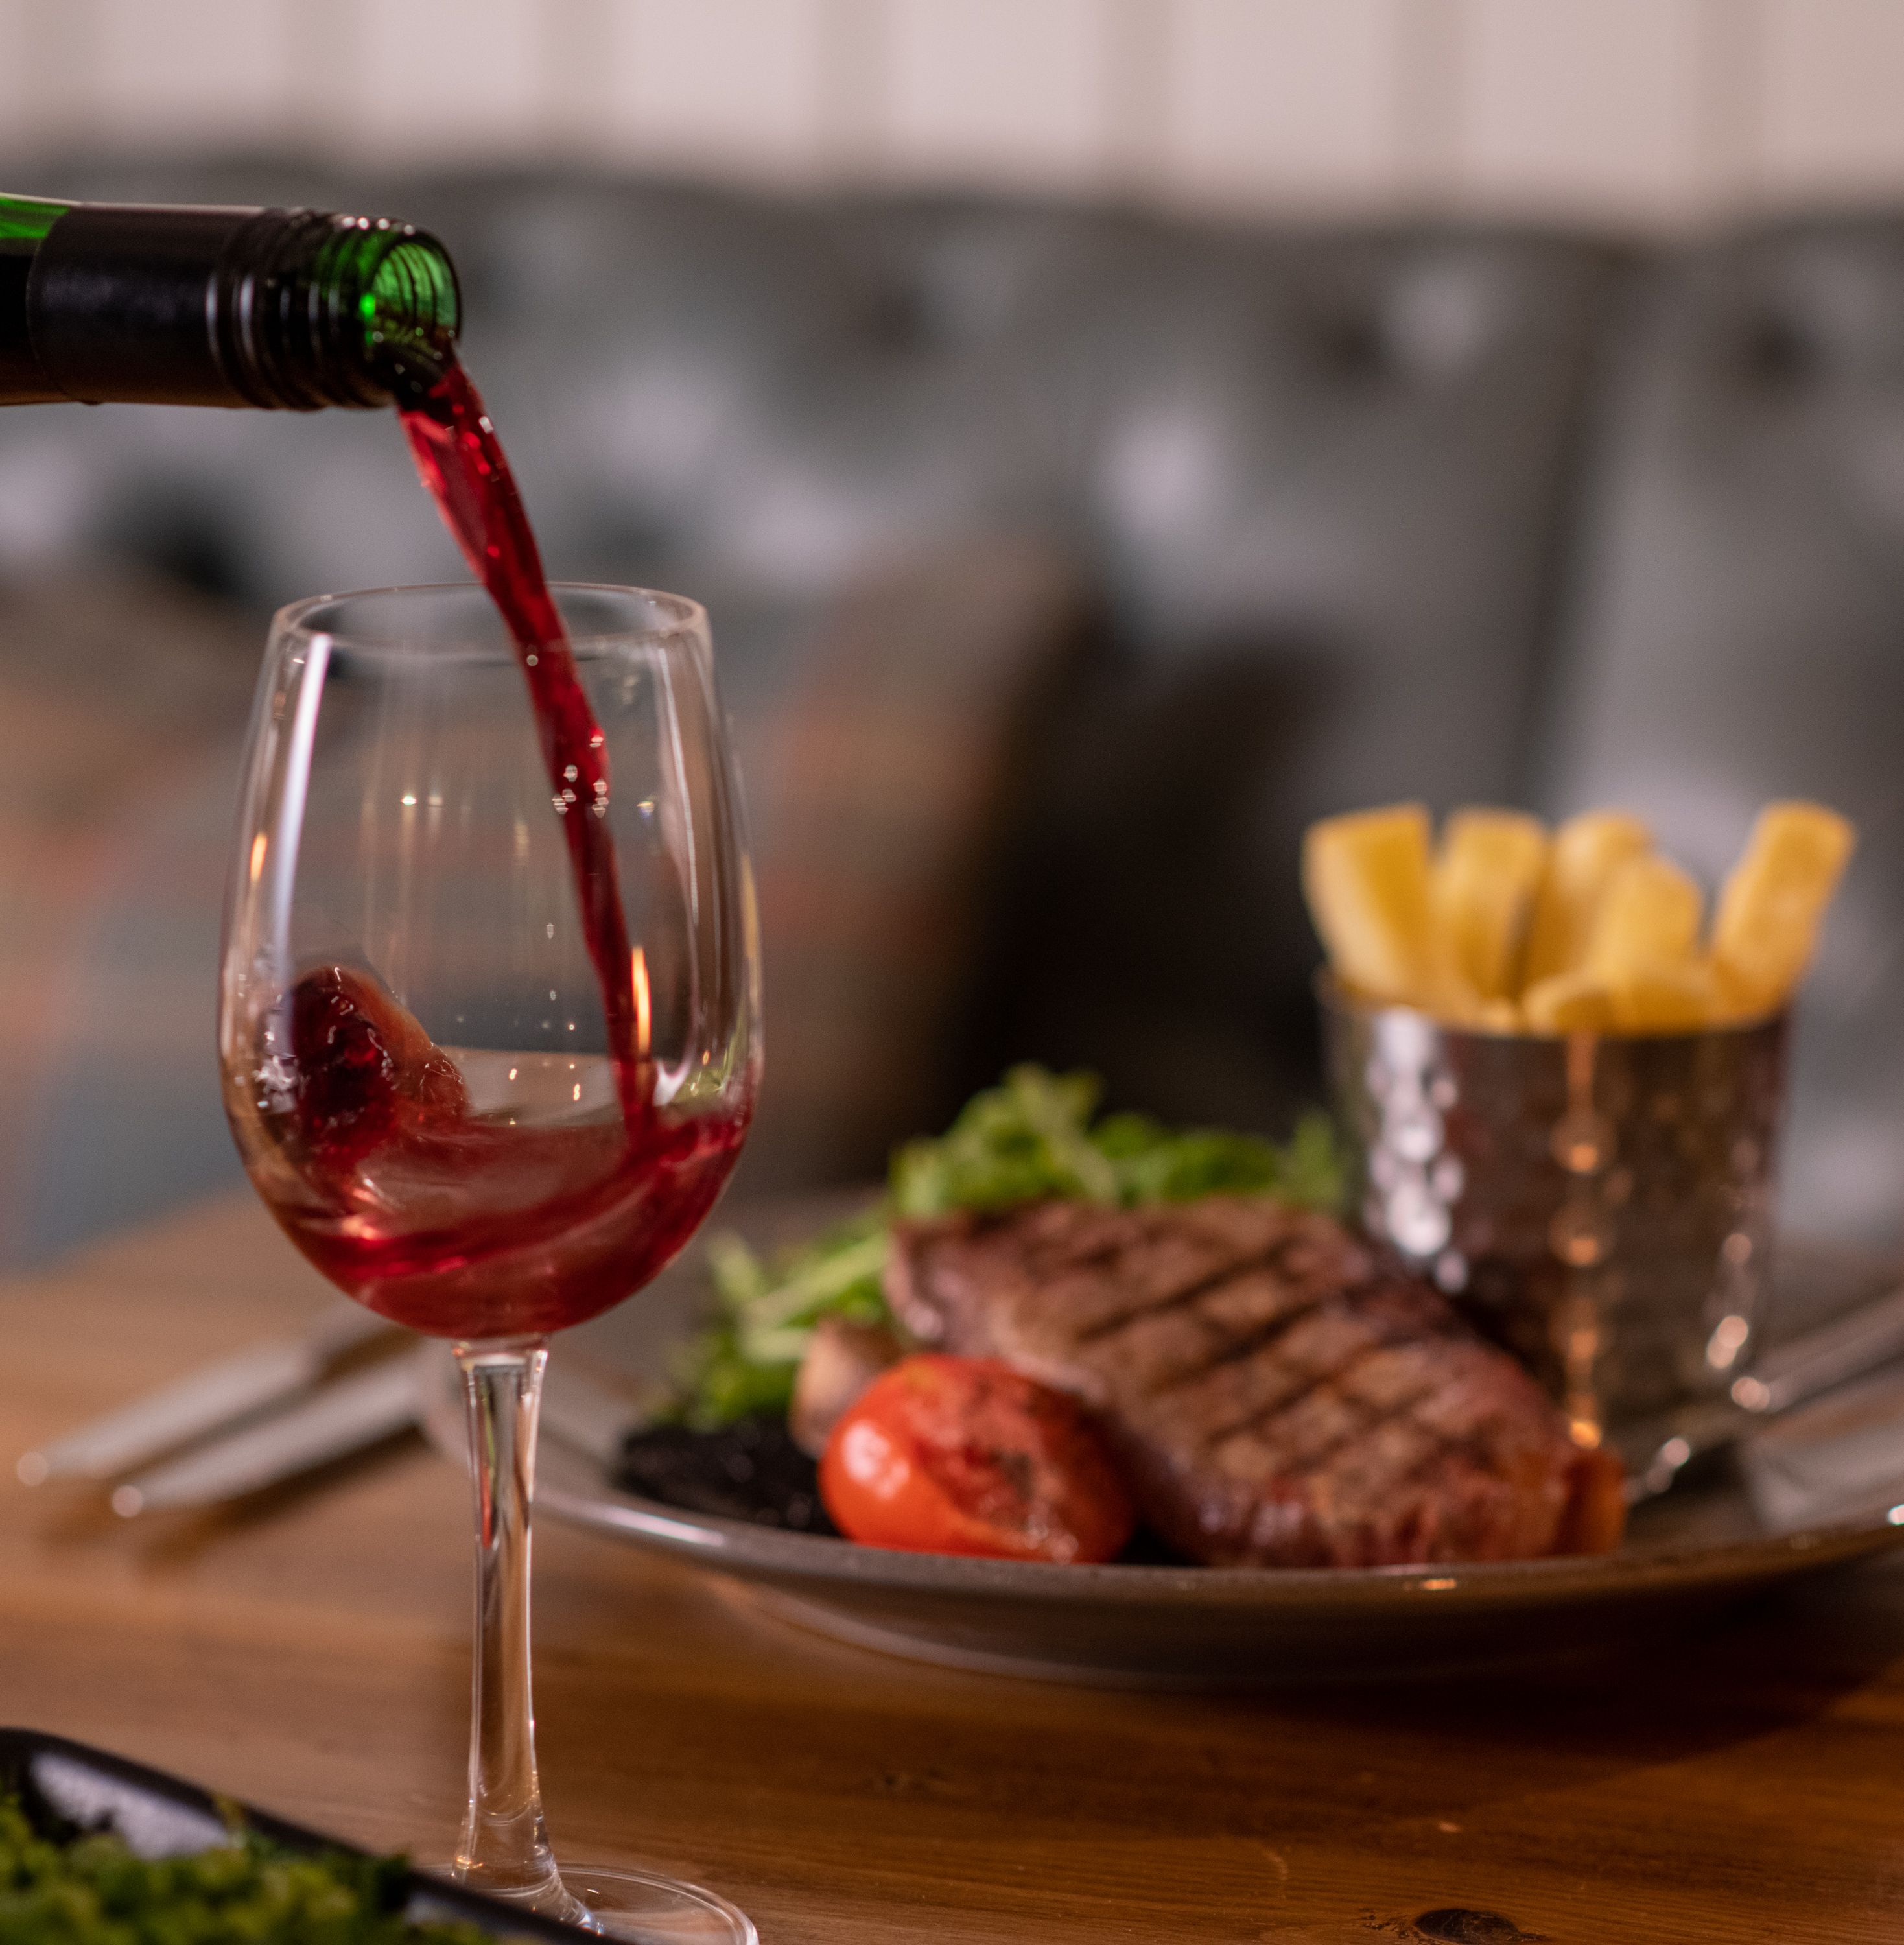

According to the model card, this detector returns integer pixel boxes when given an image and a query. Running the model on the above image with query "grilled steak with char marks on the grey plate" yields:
[887,1198,1620,1566]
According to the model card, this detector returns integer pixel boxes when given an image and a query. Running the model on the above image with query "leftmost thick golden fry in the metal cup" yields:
[1303,803,1447,1006]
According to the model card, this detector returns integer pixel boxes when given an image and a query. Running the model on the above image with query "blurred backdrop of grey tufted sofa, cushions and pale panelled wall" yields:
[0,0,1904,1262]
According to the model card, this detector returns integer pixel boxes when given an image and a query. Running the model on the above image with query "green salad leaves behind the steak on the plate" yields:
[677,1066,1342,1428]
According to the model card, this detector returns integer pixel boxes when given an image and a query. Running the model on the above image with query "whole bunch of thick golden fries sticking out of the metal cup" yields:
[1303,801,1857,1035]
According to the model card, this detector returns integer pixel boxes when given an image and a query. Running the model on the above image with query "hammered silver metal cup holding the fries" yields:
[1319,976,1787,1439]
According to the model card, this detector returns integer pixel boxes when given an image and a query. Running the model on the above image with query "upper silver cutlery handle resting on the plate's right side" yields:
[1618,1290,1904,1505]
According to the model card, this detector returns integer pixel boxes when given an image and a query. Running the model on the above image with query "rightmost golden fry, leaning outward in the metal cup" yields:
[1711,803,1857,1015]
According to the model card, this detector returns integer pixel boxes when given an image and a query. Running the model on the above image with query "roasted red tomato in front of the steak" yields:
[821,1356,1136,1562]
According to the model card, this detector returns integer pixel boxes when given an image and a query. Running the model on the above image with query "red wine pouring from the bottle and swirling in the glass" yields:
[259,364,747,1338]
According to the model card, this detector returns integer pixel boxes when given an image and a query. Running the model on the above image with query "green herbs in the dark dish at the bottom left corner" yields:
[0,1797,506,1945]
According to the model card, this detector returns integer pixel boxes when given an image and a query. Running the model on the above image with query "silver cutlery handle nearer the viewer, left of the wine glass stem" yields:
[113,1354,418,1519]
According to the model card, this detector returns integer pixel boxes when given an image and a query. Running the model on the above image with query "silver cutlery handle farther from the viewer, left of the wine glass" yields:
[14,1303,393,1486]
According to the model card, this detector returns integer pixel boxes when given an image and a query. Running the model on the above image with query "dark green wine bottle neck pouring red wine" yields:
[0,196,459,412]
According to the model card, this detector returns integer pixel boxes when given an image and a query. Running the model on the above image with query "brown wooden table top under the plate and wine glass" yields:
[11,1202,1904,1945]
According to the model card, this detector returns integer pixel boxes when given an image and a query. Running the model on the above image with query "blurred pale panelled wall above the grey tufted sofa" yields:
[0,0,1904,224]
